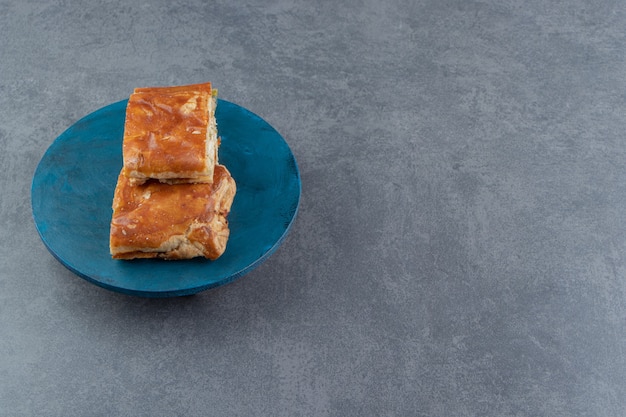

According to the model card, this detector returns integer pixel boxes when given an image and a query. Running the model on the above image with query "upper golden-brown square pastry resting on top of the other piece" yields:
[122,83,218,184]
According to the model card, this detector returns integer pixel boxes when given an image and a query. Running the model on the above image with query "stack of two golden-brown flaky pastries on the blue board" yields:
[110,83,236,260]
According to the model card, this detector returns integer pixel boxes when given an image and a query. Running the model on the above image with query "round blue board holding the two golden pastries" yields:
[31,100,301,297]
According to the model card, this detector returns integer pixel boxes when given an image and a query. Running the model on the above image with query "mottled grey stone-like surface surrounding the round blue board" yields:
[0,0,626,417]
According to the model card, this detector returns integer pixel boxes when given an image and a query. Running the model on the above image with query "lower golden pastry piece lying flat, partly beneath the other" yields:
[110,165,236,260]
